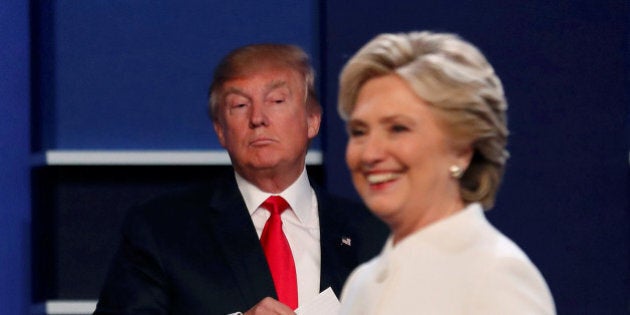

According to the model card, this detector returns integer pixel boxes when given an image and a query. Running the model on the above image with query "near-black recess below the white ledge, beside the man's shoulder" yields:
[29,165,323,302]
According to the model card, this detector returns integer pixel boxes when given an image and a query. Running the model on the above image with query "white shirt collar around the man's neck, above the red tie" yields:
[234,168,315,224]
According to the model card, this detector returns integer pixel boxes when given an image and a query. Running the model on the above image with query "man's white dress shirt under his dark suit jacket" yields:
[235,169,321,305]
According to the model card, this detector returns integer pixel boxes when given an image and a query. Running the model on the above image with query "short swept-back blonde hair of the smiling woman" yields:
[338,31,508,209]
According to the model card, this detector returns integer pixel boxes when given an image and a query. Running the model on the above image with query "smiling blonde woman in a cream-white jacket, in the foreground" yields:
[338,32,555,314]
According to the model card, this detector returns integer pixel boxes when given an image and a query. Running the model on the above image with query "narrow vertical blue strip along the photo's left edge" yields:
[0,0,30,314]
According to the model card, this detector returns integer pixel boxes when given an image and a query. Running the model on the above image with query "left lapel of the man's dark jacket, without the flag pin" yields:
[210,179,276,306]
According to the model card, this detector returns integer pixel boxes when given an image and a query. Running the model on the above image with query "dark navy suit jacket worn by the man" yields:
[95,176,388,315]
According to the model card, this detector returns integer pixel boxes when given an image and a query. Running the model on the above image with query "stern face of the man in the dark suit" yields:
[214,66,321,180]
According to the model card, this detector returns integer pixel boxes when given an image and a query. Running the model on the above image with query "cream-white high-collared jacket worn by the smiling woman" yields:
[340,203,555,315]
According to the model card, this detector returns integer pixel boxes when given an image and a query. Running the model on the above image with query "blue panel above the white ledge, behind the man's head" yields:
[38,0,319,149]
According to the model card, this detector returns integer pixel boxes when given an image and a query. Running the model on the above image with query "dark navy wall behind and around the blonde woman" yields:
[322,0,630,314]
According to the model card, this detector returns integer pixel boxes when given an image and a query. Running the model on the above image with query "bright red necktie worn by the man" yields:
[260,196,298,309]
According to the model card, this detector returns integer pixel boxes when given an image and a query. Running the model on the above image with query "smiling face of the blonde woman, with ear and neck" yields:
[346,75,470,241]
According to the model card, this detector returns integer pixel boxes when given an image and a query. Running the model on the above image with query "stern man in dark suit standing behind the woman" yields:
[95,44,387,315]
